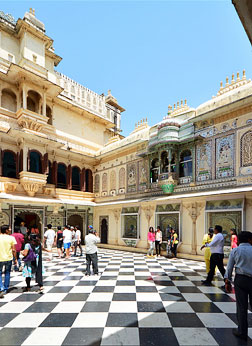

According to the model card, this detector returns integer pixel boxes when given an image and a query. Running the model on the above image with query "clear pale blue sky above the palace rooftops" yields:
[0,0,252,136]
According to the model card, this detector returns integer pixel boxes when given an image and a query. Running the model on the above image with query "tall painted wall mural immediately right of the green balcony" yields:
[196,142,212,181]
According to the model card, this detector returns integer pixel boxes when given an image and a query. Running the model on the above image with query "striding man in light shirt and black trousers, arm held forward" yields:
[200,225,225,286]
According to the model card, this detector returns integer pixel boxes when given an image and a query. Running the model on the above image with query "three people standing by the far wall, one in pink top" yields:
[147,226,179,258]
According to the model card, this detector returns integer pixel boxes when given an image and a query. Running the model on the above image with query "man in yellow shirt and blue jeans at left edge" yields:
[0,225,17,298]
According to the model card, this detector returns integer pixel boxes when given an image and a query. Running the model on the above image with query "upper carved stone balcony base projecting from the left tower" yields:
[16,108,48,132]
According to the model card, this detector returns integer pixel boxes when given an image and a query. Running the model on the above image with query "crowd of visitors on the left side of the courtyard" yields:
[0,224,100,298]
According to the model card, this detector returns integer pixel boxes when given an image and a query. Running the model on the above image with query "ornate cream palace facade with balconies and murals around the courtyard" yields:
[0,10,252,254]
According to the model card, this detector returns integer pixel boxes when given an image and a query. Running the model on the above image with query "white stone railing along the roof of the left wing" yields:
[55,71,107,118]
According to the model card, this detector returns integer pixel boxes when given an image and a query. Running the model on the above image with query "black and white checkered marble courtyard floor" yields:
[0,250,252,346]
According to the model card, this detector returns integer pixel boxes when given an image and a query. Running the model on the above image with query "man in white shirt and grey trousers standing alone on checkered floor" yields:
[85,228,100,276]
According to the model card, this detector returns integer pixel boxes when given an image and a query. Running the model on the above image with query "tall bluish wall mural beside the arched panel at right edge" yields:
[216,135,234,179]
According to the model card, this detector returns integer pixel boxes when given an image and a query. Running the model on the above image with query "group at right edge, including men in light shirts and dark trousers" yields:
[201,225,252,340]
